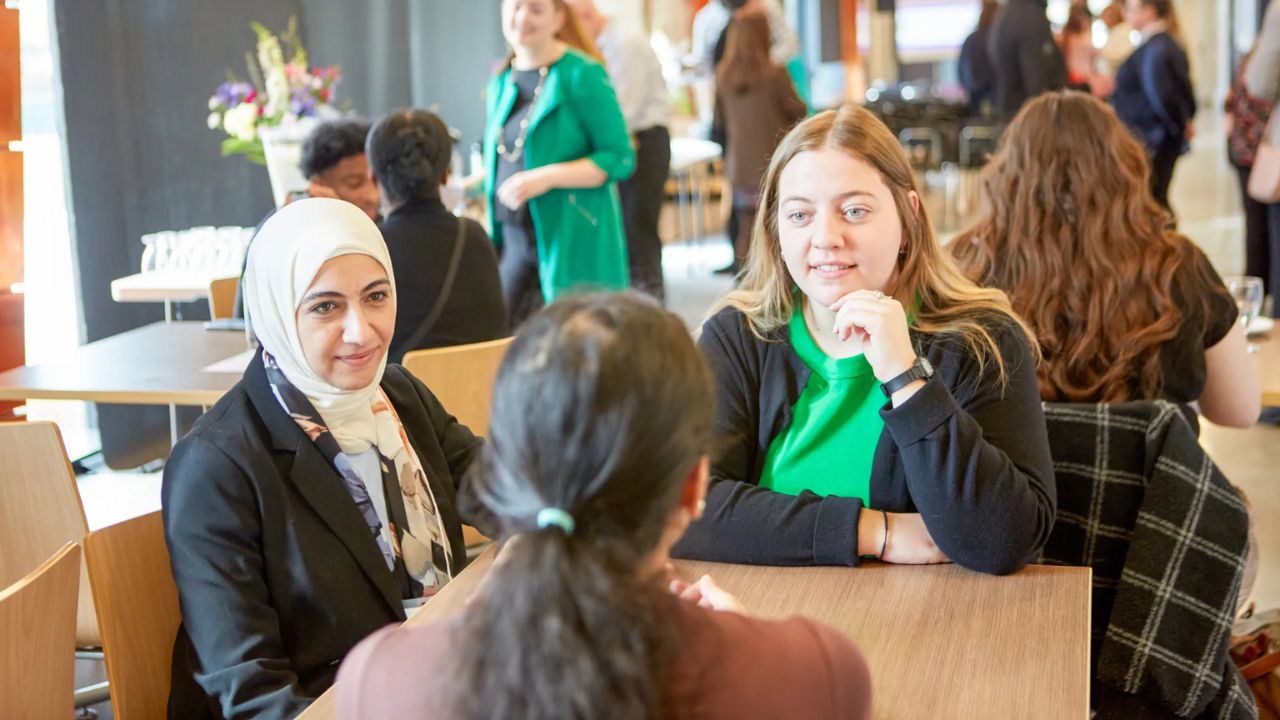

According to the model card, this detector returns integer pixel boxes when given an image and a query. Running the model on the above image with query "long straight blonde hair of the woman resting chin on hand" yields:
[712,105,1038,382]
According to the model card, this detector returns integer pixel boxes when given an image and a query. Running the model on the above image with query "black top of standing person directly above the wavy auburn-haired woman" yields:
[987,0,1066,120]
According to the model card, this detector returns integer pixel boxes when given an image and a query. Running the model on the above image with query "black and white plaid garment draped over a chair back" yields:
[1039,402,1257,720]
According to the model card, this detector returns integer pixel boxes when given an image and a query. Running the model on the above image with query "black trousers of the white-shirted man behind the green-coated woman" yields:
[618,127,671,300]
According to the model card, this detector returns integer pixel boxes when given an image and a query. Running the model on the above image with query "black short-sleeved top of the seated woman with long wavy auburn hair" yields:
[1133,242,1239,404]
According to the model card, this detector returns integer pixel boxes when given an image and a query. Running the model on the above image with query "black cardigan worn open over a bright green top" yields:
[673,309,1056,574]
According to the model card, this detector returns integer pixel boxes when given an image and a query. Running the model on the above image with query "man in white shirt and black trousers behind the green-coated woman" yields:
[567,0,671,300]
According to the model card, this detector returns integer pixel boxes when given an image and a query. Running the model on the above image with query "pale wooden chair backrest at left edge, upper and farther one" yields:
[0,423,100,647]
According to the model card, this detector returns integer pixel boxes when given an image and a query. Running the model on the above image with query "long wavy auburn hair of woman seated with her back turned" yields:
[950,91,1210,402]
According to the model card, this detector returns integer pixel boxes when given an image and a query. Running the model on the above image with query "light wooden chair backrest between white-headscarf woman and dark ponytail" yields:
[403,337,511,436]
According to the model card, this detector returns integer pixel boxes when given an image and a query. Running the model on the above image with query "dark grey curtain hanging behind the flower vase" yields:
[52,0,506,466]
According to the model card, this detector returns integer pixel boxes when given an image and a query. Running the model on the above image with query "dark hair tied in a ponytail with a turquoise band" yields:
[456,293,714,720]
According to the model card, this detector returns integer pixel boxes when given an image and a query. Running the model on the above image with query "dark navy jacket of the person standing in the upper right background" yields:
[1111,32,1196,150]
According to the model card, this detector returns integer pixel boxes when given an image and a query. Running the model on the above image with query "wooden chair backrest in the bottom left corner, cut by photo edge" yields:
[0,542,81,717]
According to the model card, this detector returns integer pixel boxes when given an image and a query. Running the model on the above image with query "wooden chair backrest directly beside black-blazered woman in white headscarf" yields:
[84,511,182,720]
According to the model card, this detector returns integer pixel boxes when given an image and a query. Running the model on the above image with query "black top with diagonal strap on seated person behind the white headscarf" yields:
[379,197,507,363]
